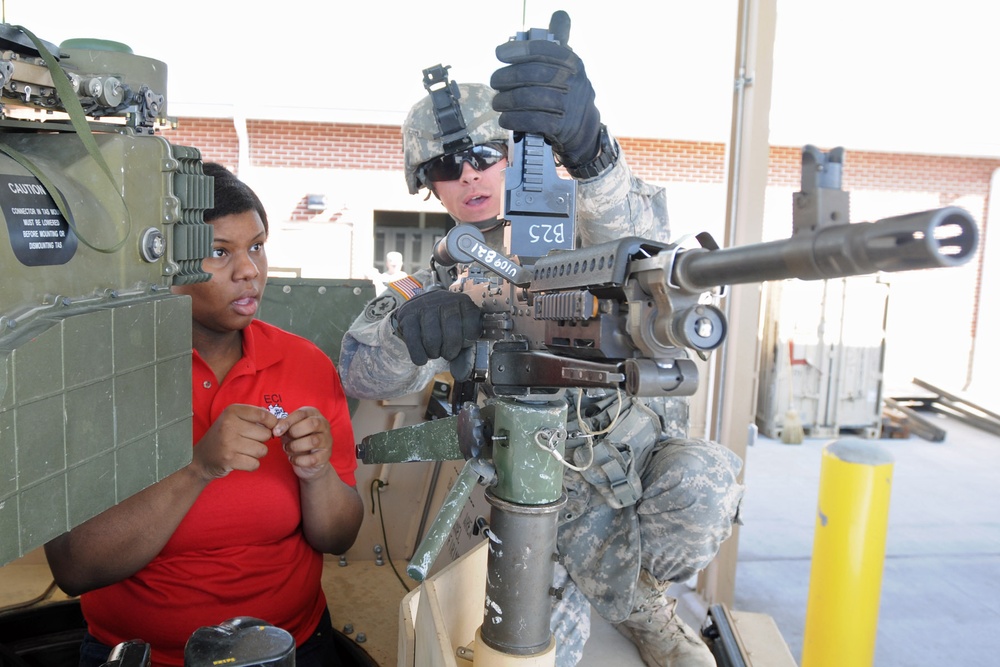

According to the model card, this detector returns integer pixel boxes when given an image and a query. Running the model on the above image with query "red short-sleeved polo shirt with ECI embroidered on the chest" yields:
[81,320,357,666]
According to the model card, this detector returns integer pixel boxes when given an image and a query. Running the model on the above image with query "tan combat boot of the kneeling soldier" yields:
[615,570,716,667]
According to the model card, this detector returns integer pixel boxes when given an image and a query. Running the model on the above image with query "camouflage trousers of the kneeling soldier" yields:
[551,399,743,667]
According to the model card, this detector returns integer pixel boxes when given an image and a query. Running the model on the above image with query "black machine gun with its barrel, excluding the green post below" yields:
[435,188,977,396]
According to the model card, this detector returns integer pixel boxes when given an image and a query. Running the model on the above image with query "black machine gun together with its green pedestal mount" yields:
[358,17,978,659]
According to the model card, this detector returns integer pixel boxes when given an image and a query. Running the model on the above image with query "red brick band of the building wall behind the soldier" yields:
[163,118,1000,205]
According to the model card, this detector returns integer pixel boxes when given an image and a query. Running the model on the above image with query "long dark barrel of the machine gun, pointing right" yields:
[672,206,979,292]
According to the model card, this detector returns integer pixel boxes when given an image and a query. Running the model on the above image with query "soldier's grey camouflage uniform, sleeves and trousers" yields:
[339,144,743,666]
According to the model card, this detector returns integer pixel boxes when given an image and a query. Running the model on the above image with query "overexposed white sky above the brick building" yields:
[3,0,1000,157]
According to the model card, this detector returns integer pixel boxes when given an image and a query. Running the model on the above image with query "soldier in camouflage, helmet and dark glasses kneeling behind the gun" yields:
[340,17,743,667]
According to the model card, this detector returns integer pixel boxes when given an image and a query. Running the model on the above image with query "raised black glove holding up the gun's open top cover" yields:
[490,11,601,167]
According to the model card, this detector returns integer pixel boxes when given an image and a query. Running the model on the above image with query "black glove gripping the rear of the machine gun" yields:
[394,289,483,366]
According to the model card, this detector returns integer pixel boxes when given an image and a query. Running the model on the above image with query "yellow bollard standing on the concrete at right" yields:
[802,438,893,667]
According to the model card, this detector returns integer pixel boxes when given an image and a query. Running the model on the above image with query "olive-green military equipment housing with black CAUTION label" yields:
[0,24,213,563]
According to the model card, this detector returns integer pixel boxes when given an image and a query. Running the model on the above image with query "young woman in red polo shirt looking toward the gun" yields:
[45,164,363,667]
